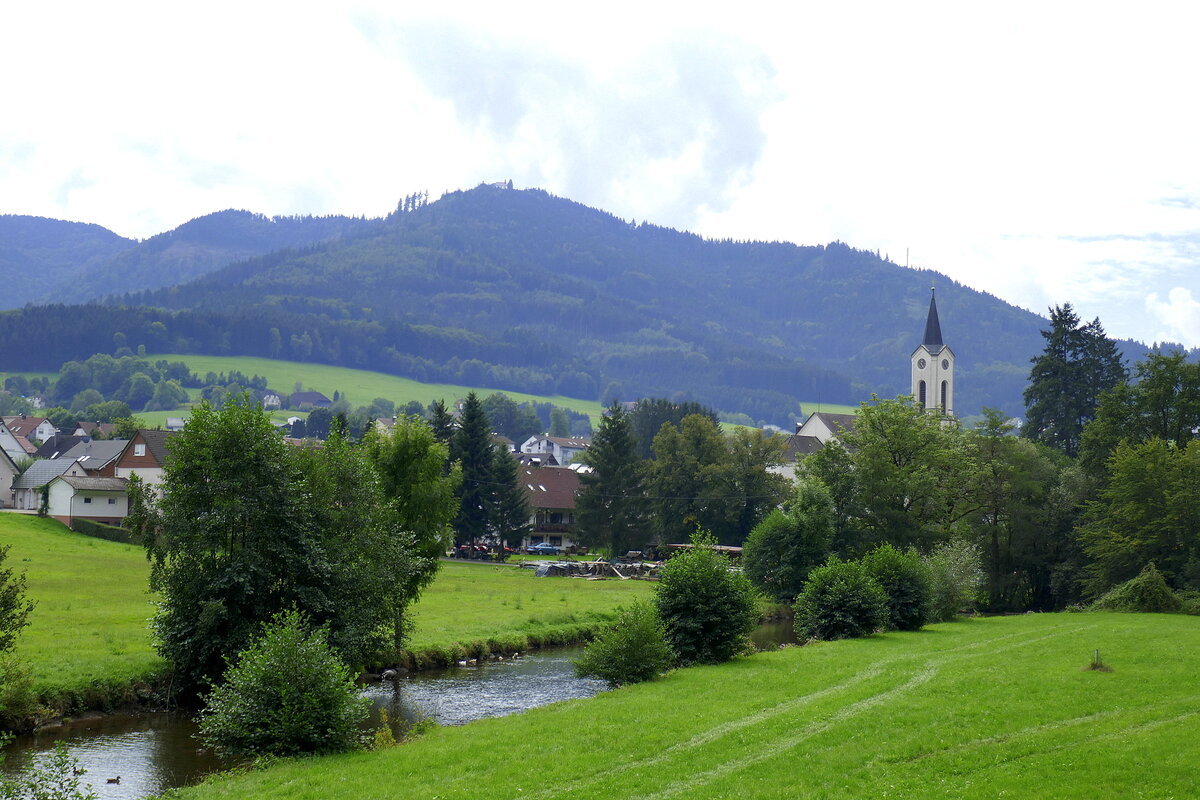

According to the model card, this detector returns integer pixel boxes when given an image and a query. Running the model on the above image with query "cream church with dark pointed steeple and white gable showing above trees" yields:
[784,288,954,463]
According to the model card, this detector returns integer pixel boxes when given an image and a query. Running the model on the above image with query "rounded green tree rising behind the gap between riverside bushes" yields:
[742,479,834,603]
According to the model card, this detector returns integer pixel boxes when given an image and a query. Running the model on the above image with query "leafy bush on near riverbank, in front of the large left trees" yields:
[199,610,367,756]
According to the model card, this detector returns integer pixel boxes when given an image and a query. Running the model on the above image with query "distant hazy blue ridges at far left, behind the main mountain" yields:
[0,210,378,308]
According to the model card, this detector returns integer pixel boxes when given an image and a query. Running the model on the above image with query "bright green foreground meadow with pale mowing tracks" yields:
[169,614,1200,800]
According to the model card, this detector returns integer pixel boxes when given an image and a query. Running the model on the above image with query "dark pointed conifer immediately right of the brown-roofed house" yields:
[575,403,649,555]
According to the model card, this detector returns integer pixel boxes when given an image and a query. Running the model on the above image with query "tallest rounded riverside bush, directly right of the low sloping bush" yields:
[654,533,758,664]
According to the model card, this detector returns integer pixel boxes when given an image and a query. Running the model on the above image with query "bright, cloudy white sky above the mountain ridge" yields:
[0,1,1200,348]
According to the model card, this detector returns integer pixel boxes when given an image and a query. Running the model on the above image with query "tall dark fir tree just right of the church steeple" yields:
[1022,303,1127,458]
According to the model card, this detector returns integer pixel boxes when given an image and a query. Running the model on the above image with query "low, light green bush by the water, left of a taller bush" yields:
[575,601,674,686]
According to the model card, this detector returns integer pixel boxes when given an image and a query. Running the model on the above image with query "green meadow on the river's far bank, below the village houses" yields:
[0,513,649,698]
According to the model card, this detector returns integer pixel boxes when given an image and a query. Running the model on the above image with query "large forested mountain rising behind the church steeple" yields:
[0,186,1156,423]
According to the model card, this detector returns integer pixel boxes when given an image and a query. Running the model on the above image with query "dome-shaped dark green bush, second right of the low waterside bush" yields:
[796,557,888,639]
